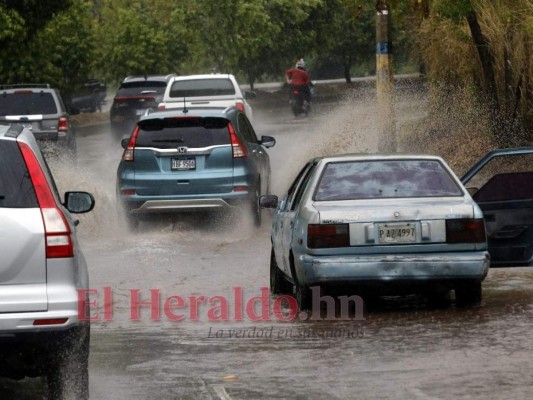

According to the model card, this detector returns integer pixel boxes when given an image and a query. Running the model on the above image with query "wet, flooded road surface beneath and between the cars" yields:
[0,84,533,400]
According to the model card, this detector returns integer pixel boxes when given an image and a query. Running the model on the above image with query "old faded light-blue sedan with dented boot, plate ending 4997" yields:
[260,154,490,309]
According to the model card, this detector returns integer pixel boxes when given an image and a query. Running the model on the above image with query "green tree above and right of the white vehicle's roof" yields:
[190,0,321,87]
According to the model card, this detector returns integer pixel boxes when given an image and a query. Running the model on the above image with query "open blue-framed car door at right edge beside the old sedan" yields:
[461,147,533,267]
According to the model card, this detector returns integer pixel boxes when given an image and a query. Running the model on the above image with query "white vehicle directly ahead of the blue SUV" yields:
[158,74,255,121]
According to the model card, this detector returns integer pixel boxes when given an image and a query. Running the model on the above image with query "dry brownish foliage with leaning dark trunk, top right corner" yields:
[417,0,533,146]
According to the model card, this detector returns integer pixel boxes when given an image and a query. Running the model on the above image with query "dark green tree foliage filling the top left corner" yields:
[0,0,94,94]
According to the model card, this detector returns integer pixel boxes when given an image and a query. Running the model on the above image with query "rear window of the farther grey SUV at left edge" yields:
[0,90,58,115]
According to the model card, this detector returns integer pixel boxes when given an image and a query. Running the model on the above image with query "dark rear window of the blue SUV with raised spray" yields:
[135,118,231,149]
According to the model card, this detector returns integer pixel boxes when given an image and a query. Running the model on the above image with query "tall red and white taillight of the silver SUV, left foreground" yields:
[19,143,74,258]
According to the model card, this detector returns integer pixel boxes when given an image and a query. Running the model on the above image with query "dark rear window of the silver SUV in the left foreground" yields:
[0,140,39,208]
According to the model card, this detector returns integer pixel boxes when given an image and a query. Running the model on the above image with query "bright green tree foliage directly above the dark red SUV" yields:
[95,0,191,82]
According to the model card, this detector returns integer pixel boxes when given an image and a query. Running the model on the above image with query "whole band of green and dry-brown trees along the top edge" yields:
[0,0,533,141]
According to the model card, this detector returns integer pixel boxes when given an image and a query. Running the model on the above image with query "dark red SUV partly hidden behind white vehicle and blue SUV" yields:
[109,74,174,136]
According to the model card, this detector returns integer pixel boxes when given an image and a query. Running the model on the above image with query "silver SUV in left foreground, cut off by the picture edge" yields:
[0,124,94,399]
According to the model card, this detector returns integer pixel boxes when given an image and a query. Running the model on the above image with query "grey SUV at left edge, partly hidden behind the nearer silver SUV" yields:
[0,84,76,156]
